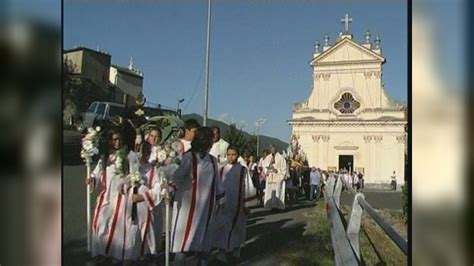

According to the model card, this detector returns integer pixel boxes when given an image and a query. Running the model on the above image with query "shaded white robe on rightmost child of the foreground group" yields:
[211,163,256,251]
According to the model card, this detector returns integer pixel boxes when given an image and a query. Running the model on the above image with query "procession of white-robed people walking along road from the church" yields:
[81,113,362,265]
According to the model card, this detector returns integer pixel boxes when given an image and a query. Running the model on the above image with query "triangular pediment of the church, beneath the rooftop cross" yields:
[310,38,385,65]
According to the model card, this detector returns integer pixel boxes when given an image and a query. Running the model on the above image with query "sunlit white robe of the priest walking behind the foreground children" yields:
[262,153,287,209]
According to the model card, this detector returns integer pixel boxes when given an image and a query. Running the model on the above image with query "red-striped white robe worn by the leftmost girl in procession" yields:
[91,154,128,260]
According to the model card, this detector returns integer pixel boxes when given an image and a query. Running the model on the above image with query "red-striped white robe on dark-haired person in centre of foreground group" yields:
[170,152,225,253]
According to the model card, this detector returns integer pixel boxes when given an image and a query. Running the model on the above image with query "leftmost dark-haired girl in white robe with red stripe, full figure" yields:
[88,129,127,260]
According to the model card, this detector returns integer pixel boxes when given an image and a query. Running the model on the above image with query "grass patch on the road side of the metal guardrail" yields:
[279,201,334,265]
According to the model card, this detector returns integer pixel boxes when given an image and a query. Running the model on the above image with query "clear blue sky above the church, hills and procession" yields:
[63,1,407,141]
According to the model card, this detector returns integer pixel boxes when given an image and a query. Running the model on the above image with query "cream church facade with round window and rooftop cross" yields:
[288,15,407,184]
